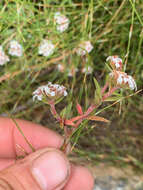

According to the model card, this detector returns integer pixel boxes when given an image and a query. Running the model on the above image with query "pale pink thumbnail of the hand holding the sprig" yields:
[31,151,69,190]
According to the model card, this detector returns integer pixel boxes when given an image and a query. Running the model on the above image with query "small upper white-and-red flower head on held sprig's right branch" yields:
[106,55,122,71]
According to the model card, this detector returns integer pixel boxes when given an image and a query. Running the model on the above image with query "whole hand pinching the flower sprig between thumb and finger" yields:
[0,118,93,190]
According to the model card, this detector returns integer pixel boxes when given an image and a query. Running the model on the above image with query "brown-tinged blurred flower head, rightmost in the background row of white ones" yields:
[75,41,93,56]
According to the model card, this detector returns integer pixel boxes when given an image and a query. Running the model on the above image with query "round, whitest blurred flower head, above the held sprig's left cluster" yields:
[39,40,55,57]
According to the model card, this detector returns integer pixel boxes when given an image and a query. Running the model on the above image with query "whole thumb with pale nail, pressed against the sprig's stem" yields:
[0,148,70,190]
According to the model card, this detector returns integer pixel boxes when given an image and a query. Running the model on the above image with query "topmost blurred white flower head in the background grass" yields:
[54,12,69,33]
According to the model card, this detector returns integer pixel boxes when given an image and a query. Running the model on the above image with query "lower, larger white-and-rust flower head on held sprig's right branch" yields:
[109,71,137,91]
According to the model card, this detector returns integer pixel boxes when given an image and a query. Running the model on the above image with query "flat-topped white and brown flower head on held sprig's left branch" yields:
[33,82,67,101]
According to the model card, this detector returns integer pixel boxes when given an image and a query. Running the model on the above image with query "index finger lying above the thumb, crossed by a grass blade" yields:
[0,117,63,158]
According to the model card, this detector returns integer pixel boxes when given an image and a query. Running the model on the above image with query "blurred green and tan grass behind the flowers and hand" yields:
[0,0,143,169]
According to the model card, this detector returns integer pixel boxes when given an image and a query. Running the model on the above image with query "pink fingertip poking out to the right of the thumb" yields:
[64,165,94,190]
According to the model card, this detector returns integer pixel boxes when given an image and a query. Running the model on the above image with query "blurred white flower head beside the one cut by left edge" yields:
[9,40,23,57]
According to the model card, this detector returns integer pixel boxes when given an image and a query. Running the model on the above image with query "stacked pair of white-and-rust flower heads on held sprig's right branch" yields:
[106,56,137,91]
